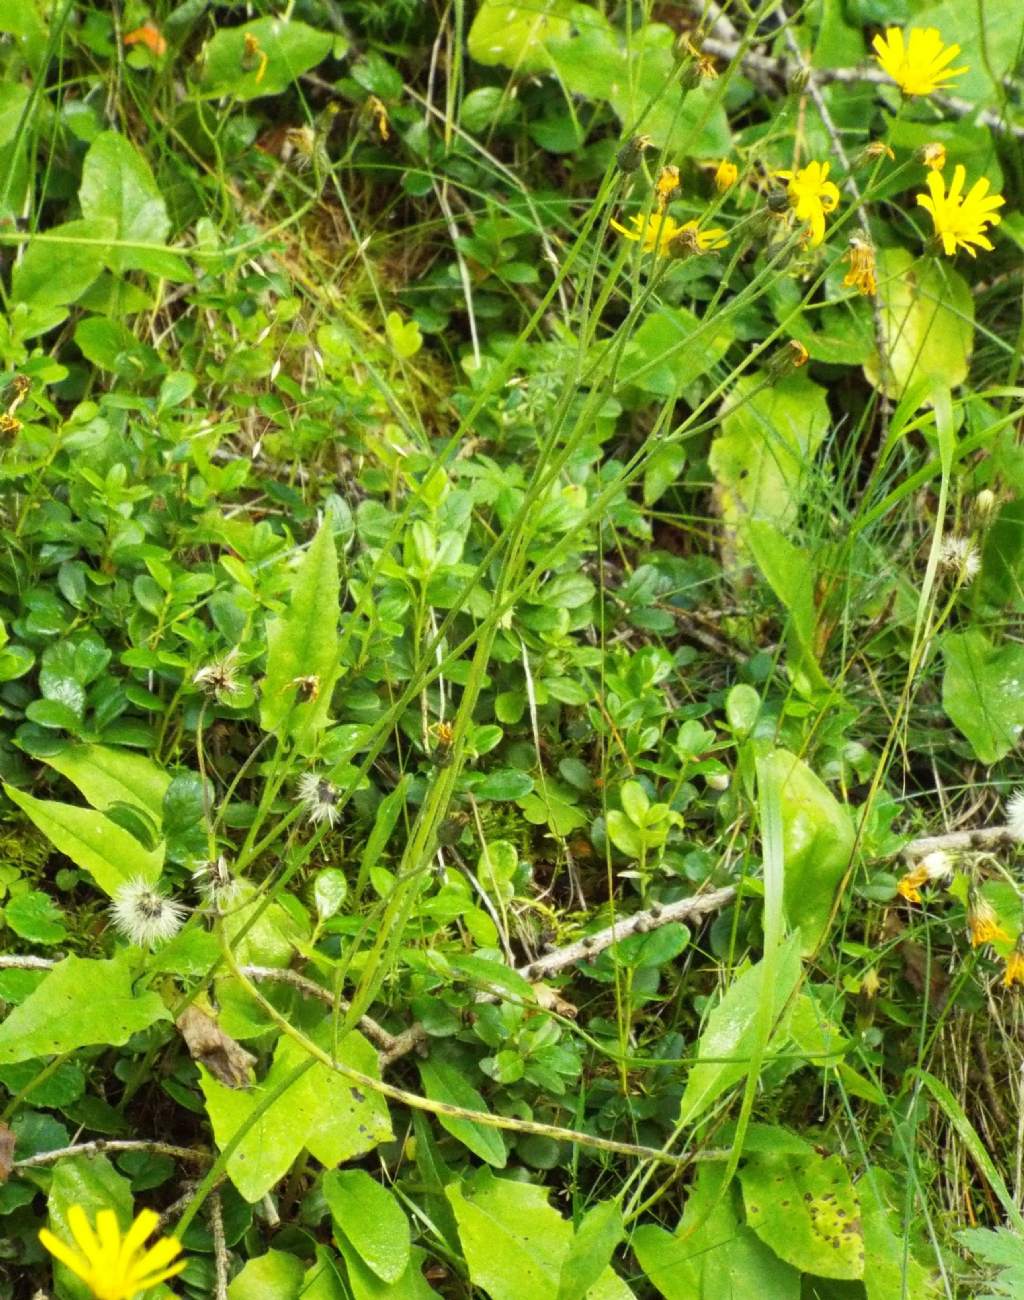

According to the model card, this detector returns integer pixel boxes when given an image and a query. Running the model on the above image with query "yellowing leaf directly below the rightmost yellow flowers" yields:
[864,247,975,400]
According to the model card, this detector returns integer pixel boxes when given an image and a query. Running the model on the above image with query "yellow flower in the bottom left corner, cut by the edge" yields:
[39,1205,185,1300]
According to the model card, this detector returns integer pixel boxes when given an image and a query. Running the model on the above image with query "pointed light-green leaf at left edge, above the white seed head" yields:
[4,785,164,897]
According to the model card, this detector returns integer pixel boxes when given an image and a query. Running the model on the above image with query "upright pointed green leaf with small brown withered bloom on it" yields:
[260,521,339,754]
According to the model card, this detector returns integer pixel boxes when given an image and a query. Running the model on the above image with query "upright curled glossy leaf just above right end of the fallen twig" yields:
[762,749,855,954]
